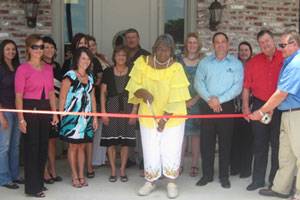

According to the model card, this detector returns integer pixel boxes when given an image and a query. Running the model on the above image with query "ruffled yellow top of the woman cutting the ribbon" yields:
[126,56,191,128]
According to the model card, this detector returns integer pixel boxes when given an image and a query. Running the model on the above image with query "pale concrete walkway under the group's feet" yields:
[0,160,276,200]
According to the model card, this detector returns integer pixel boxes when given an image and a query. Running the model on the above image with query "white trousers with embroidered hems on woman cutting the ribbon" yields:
[141,123,185,182]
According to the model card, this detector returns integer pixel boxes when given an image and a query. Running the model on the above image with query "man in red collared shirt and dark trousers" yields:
[242,30,283,191]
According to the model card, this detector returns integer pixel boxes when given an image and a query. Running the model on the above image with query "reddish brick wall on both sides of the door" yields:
[0,0,299,58]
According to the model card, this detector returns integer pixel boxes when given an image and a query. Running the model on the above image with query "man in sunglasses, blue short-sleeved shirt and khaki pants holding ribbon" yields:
[250,31,300,200]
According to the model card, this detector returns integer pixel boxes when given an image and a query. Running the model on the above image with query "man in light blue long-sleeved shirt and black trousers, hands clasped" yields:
[194,32,244,188]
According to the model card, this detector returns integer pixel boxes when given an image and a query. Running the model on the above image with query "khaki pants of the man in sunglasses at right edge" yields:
[272,111,300,194]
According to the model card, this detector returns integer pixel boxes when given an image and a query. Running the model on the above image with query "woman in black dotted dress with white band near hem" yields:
[100,46,137,182]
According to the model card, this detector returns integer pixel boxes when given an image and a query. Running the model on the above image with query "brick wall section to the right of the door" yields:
[197,0,299,52]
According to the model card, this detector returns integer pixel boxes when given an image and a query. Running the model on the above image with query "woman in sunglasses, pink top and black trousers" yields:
[15,34,58,197]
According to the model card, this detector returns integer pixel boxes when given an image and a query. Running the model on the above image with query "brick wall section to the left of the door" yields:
[0,0,52,59]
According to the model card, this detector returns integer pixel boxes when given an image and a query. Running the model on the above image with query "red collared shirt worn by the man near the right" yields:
[244,49,283,101]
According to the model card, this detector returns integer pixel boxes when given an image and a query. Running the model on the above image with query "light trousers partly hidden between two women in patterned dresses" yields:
[92,120,106,166]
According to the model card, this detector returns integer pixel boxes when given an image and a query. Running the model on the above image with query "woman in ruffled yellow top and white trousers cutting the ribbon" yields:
[126,34,191,198]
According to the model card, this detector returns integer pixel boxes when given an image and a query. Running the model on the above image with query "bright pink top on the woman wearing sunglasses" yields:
[15,63,54,99]
